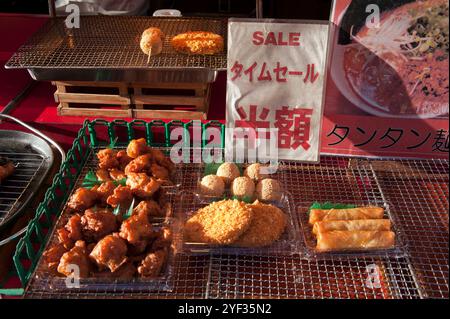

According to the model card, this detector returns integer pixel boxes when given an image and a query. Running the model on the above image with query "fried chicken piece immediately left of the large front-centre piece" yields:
[58,240,91,278]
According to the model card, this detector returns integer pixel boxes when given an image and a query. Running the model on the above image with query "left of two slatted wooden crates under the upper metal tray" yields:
[53,82,133,117]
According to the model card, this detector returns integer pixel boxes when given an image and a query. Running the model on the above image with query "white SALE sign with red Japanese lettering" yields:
[226,19,328,162]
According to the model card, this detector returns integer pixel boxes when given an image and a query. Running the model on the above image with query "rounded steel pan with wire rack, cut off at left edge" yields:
[0,130,54,230]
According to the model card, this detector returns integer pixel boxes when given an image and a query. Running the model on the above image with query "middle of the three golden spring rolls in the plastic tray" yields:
[313,219,391,236]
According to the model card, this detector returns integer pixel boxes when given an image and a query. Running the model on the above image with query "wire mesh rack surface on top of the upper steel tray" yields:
[6,16,227,70]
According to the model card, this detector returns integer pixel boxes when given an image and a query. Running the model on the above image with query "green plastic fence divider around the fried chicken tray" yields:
[0,120,225,296]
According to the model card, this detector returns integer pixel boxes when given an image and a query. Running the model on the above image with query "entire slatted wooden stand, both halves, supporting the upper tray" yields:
[53,82,211,120]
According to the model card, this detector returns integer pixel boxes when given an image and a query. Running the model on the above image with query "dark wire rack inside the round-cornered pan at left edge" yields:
[0,152,45,225]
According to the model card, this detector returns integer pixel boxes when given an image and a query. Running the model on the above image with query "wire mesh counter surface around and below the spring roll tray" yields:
[26,157,449,299]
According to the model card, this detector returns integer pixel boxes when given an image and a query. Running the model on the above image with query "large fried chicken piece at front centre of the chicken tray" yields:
[89,233,128,272]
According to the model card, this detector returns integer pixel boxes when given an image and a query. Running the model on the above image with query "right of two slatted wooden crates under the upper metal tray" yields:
[131,83,211,120]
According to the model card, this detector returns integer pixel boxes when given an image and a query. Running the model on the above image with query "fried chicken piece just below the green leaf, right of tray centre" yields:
[119,212,153,245]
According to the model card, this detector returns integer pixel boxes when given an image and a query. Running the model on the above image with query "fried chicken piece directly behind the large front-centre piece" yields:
[81,208,118,242]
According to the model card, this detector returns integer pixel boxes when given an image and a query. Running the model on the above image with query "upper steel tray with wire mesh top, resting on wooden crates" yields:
[5,16,227,83]
